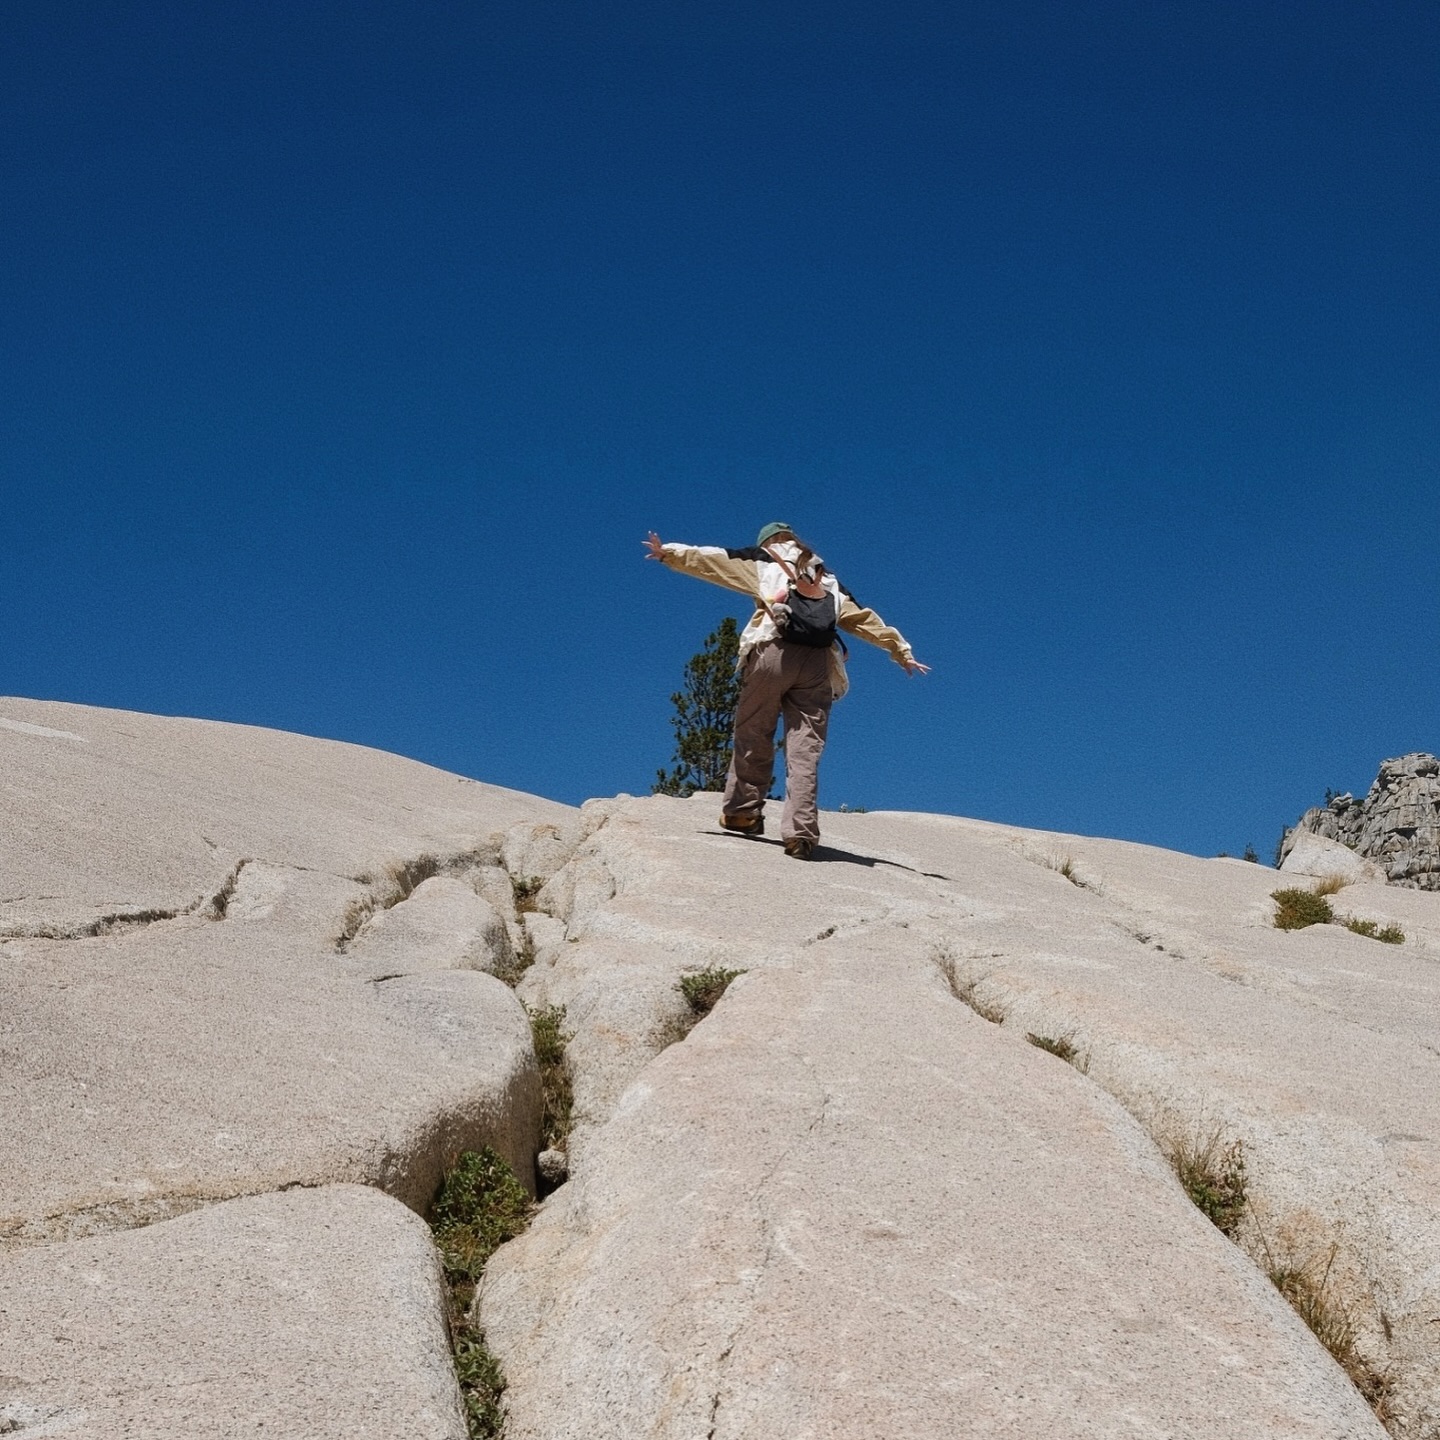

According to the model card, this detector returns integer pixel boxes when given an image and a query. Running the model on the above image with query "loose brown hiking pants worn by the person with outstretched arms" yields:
[723,641,832,841]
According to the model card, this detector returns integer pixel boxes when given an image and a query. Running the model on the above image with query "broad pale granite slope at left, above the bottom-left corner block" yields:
[0,700,575,1238]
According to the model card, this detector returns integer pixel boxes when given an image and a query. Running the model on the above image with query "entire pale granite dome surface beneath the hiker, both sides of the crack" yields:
[0,700,1440,1440]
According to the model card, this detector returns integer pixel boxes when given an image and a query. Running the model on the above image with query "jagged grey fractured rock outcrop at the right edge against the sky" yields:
[1280,753,1440,890]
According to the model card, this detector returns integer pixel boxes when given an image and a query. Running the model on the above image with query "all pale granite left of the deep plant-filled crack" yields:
[0,700,579,1440]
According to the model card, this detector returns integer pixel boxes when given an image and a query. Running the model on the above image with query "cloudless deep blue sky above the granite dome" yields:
[0,0,1440,854]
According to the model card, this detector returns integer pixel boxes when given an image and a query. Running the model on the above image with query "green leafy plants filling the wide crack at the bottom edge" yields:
[429,1145,534,1440]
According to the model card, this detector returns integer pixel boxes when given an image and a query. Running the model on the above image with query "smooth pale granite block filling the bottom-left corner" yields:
[0,1185,465,1440]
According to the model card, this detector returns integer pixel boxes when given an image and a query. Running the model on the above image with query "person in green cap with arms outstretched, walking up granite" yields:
[645,520,930,860]
